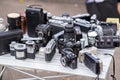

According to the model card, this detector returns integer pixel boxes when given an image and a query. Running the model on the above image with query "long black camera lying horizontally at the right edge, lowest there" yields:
[97,36,120,48]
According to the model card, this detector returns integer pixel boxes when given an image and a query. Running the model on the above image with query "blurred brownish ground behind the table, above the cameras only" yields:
[0,0,86,23]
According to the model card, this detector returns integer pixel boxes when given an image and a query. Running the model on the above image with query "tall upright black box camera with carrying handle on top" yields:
[26,5,47,37]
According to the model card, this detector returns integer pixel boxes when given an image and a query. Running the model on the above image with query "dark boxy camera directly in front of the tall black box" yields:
[36,24,52,47]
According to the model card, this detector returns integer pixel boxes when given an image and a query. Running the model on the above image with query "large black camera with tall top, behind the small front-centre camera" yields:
[57,25,82,54]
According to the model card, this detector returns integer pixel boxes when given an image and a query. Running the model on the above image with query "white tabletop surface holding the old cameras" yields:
[0,49,114,79]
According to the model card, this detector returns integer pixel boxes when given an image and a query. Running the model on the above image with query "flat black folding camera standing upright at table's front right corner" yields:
[84,52,103,74]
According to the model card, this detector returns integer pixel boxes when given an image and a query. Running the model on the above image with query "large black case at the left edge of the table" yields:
[0,29,23,55]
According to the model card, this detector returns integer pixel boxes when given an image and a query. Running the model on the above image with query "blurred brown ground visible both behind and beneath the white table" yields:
[0,0,120,80]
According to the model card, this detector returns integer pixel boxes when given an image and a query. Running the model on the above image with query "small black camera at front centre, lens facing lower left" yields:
[60,48,77,69]
